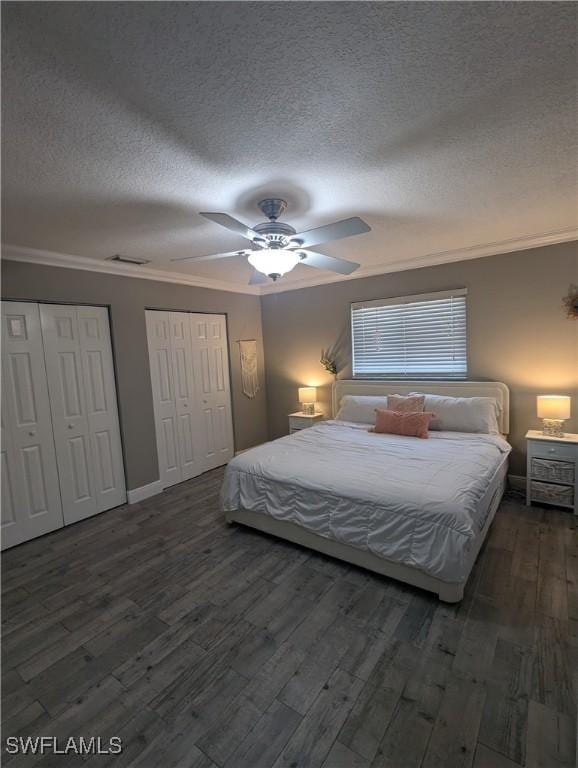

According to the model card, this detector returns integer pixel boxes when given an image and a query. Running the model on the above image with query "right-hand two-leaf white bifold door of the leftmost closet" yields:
[40,304,126,523]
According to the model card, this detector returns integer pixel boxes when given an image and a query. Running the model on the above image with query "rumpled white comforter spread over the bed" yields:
[222,421,510,582]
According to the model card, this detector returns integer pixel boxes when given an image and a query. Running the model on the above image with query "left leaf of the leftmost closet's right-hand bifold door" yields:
[40,304,99,524]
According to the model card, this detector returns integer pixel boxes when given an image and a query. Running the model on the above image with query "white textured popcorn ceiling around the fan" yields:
[2,2,578,290]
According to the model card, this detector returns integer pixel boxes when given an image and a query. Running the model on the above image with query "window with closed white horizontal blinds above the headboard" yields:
[351,288,468,379]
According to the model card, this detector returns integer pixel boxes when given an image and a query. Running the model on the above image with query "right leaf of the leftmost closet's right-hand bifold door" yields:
[77,307,126,512]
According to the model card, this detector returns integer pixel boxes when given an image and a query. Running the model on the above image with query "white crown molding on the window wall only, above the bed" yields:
[260,227,578,296]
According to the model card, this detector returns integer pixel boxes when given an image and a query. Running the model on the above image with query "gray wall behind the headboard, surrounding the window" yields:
[262,242,578,474]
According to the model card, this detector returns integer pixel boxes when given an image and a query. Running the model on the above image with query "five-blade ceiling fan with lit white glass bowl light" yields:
[172,197,371,285]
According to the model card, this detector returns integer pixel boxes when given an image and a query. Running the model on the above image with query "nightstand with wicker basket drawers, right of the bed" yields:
[526,429,578,515]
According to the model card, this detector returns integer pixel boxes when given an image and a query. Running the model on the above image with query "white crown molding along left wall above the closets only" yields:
[2,244,260,296]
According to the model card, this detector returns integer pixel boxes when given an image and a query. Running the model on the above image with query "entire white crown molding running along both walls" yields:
[2,227,578,296]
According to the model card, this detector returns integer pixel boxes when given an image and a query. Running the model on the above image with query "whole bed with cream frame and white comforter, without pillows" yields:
[222,380,510,602]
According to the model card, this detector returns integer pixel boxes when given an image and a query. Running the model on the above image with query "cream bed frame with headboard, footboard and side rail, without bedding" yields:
[226,379,510,603]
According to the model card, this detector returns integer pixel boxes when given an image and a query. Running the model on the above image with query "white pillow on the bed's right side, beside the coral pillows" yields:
[411,392,500,434]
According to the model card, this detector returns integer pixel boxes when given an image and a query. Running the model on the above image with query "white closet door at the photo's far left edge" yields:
[2,301,64,549]
